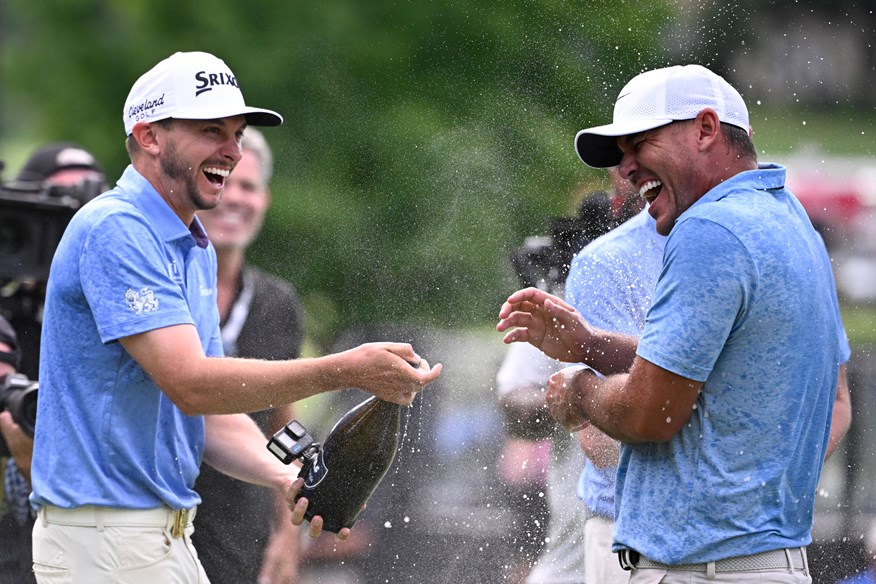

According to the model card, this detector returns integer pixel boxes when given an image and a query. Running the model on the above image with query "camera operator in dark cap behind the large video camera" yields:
[6,142,107,379]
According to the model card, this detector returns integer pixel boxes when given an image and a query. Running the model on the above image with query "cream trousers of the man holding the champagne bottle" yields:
[33,506,210,584]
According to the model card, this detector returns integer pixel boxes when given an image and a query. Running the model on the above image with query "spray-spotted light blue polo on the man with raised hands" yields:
[614,165,849,564]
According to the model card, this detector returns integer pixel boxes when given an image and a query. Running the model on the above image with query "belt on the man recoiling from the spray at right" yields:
[618,547,809,573]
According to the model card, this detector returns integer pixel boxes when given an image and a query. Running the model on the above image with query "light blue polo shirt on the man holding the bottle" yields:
[31,166,222,509]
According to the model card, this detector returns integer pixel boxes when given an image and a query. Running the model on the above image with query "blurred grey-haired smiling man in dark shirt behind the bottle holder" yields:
[192,128,303,584]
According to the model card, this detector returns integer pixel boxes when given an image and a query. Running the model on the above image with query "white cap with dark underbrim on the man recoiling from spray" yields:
[575,65,749,168]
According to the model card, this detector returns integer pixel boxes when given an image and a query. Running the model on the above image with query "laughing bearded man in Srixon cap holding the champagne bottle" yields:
[31,52,441,584]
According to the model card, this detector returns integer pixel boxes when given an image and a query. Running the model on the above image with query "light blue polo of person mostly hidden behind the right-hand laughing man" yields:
[566,209,666,519]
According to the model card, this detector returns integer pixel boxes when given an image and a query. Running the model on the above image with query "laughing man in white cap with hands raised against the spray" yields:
[497,65,849,584]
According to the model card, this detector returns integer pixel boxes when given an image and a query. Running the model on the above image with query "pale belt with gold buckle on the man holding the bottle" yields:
[39,505,198,537]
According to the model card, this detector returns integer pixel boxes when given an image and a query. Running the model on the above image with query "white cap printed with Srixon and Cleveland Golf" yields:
[122,52,283,136]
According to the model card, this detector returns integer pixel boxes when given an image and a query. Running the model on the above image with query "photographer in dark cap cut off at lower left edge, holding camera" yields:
[0,317,36,584]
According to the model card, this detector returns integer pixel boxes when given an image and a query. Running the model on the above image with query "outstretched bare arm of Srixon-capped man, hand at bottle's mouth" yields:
[119,325,441,416]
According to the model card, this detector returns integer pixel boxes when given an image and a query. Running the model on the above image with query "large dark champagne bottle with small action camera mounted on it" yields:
[268,397,401,533]
